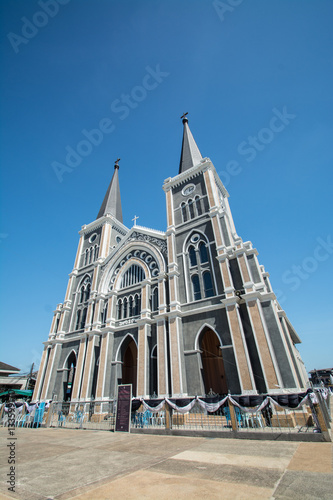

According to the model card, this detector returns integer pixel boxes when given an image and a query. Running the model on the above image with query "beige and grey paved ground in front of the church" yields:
[0,428,333,500]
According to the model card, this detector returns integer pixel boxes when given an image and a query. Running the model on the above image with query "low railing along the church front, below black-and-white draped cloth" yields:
[0,391,332,435]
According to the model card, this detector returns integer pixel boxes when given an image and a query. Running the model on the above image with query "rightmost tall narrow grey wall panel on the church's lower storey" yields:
[261,302,297,387]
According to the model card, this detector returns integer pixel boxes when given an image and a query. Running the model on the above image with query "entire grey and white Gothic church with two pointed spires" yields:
[34,116,308,403]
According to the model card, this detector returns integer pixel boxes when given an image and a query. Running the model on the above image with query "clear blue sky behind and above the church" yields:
[0,0,333,371]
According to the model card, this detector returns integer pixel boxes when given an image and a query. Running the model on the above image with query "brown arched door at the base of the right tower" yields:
[200,328,228,394]
